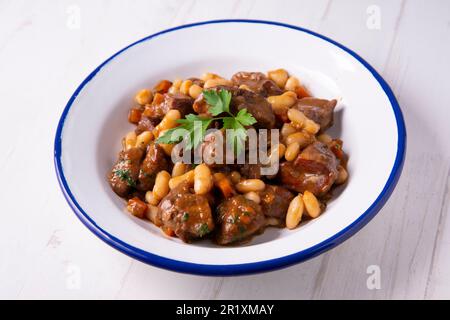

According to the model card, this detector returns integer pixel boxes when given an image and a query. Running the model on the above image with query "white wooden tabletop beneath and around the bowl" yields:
[0,0,450,299]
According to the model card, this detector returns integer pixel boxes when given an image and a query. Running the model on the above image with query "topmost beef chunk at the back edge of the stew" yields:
[231,71,283,97]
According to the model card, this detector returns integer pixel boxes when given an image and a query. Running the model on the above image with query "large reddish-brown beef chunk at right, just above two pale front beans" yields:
[280,142,338,196]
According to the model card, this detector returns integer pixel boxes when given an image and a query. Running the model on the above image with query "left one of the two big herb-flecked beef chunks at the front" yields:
[159,183,214,242]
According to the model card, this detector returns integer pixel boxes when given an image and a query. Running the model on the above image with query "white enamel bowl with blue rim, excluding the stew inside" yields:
[55,20,406,275]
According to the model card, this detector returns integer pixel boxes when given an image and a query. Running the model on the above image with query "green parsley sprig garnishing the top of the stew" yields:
[156,89,256,155]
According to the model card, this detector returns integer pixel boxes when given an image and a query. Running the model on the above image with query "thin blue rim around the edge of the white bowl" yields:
[54,19,406,276]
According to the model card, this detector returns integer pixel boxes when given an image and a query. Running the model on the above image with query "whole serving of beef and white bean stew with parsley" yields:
[108,69,348,245]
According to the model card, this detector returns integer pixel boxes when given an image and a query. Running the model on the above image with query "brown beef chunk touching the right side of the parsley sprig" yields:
[231,89,275,129]
